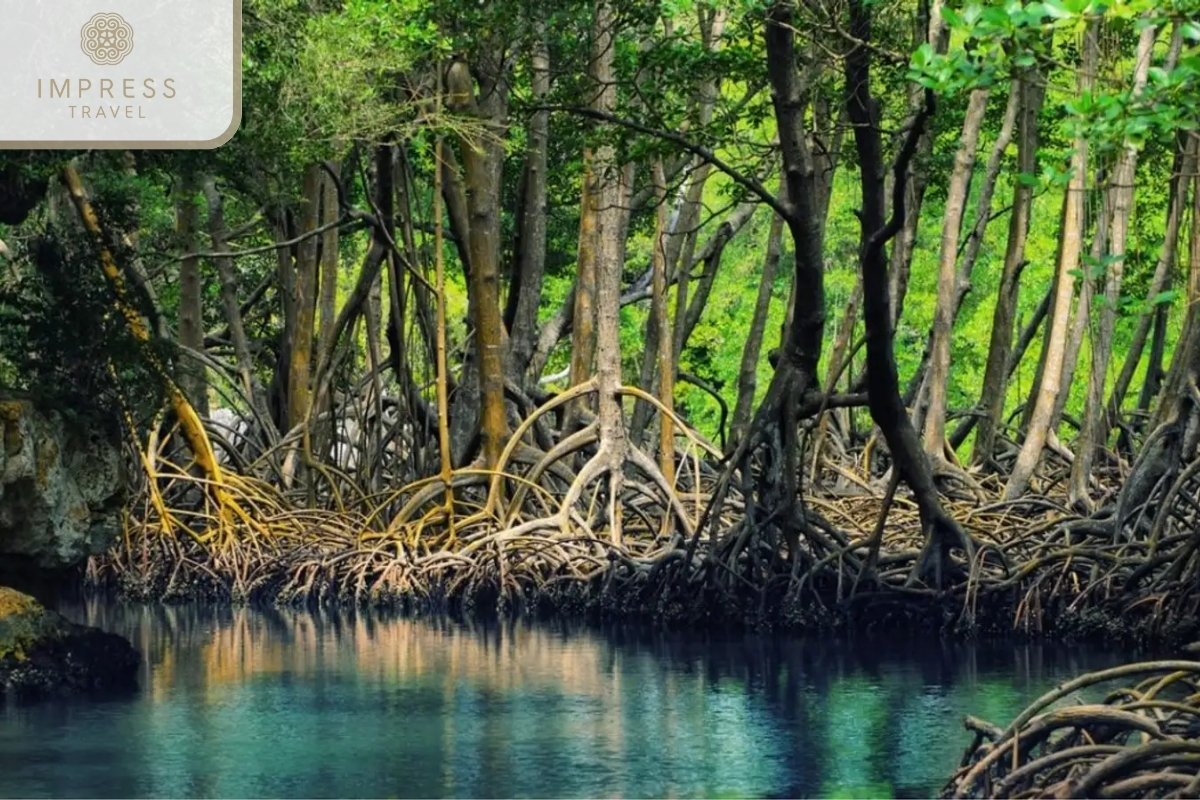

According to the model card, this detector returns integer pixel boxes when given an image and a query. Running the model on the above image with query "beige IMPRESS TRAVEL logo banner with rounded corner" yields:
[0,0,241,150]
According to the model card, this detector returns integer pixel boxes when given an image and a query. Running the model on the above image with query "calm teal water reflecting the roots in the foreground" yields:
[0,603,1121,798]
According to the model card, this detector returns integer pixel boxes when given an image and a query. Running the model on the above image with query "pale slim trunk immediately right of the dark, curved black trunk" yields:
[925,89,989,459]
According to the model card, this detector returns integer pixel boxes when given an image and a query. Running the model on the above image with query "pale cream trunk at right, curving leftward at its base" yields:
[1004,22,1098,500]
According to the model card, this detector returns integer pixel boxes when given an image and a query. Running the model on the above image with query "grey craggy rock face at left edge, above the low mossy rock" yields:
[0,399,125,572]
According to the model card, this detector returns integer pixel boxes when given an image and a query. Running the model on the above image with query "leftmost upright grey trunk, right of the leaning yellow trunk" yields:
[175,176,209,416]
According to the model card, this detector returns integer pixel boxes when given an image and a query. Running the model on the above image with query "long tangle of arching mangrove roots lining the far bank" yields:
[90,384,1200,640]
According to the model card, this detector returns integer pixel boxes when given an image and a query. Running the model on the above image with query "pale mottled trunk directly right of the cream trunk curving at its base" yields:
[1069,20,1158,511]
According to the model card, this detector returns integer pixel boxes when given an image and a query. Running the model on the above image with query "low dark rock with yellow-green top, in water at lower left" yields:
[0,587,140,699]
